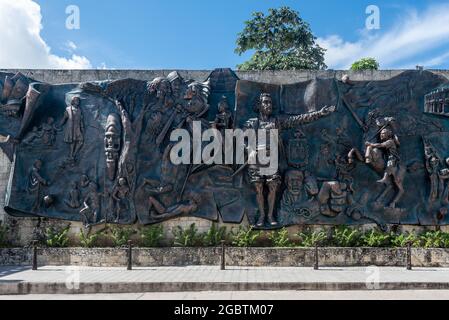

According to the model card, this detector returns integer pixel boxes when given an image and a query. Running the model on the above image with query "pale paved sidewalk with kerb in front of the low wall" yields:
[0,266,449,295]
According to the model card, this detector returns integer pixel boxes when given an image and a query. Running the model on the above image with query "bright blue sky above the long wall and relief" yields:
[0,0,449,69]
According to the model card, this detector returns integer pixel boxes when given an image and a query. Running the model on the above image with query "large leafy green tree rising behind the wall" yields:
[235,7,327,70]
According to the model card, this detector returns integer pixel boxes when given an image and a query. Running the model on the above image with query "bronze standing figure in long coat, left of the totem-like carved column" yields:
[59,97,84,160]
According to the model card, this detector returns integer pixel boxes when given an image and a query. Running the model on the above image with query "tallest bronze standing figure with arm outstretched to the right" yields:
[246,93,336,227]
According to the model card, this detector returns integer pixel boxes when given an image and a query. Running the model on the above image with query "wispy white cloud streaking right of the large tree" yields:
[318,4,449,69]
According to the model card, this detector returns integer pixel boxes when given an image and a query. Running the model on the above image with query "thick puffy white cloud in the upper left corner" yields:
[0,0,92,69]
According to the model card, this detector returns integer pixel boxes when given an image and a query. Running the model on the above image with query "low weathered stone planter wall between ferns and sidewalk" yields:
[0,248,449,268]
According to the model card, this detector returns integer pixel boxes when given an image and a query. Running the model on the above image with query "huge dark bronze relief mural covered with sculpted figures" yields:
[0,69,449,229]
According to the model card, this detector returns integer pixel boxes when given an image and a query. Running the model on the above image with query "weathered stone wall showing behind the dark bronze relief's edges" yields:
[0,70,449,245]
